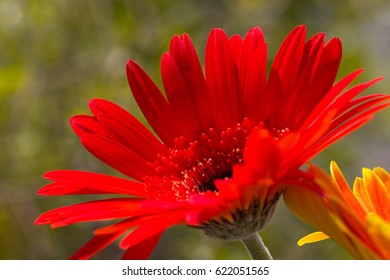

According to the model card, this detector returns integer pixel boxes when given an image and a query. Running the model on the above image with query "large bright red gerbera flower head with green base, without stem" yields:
[36,26,389,259]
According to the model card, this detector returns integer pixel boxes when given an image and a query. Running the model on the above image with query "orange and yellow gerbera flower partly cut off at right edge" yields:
[284,162,390,259]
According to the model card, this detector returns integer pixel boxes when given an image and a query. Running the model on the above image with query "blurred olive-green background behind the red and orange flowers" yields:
[0,0,390,259]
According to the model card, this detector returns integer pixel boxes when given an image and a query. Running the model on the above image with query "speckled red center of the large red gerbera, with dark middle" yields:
[145,119,252,200]
